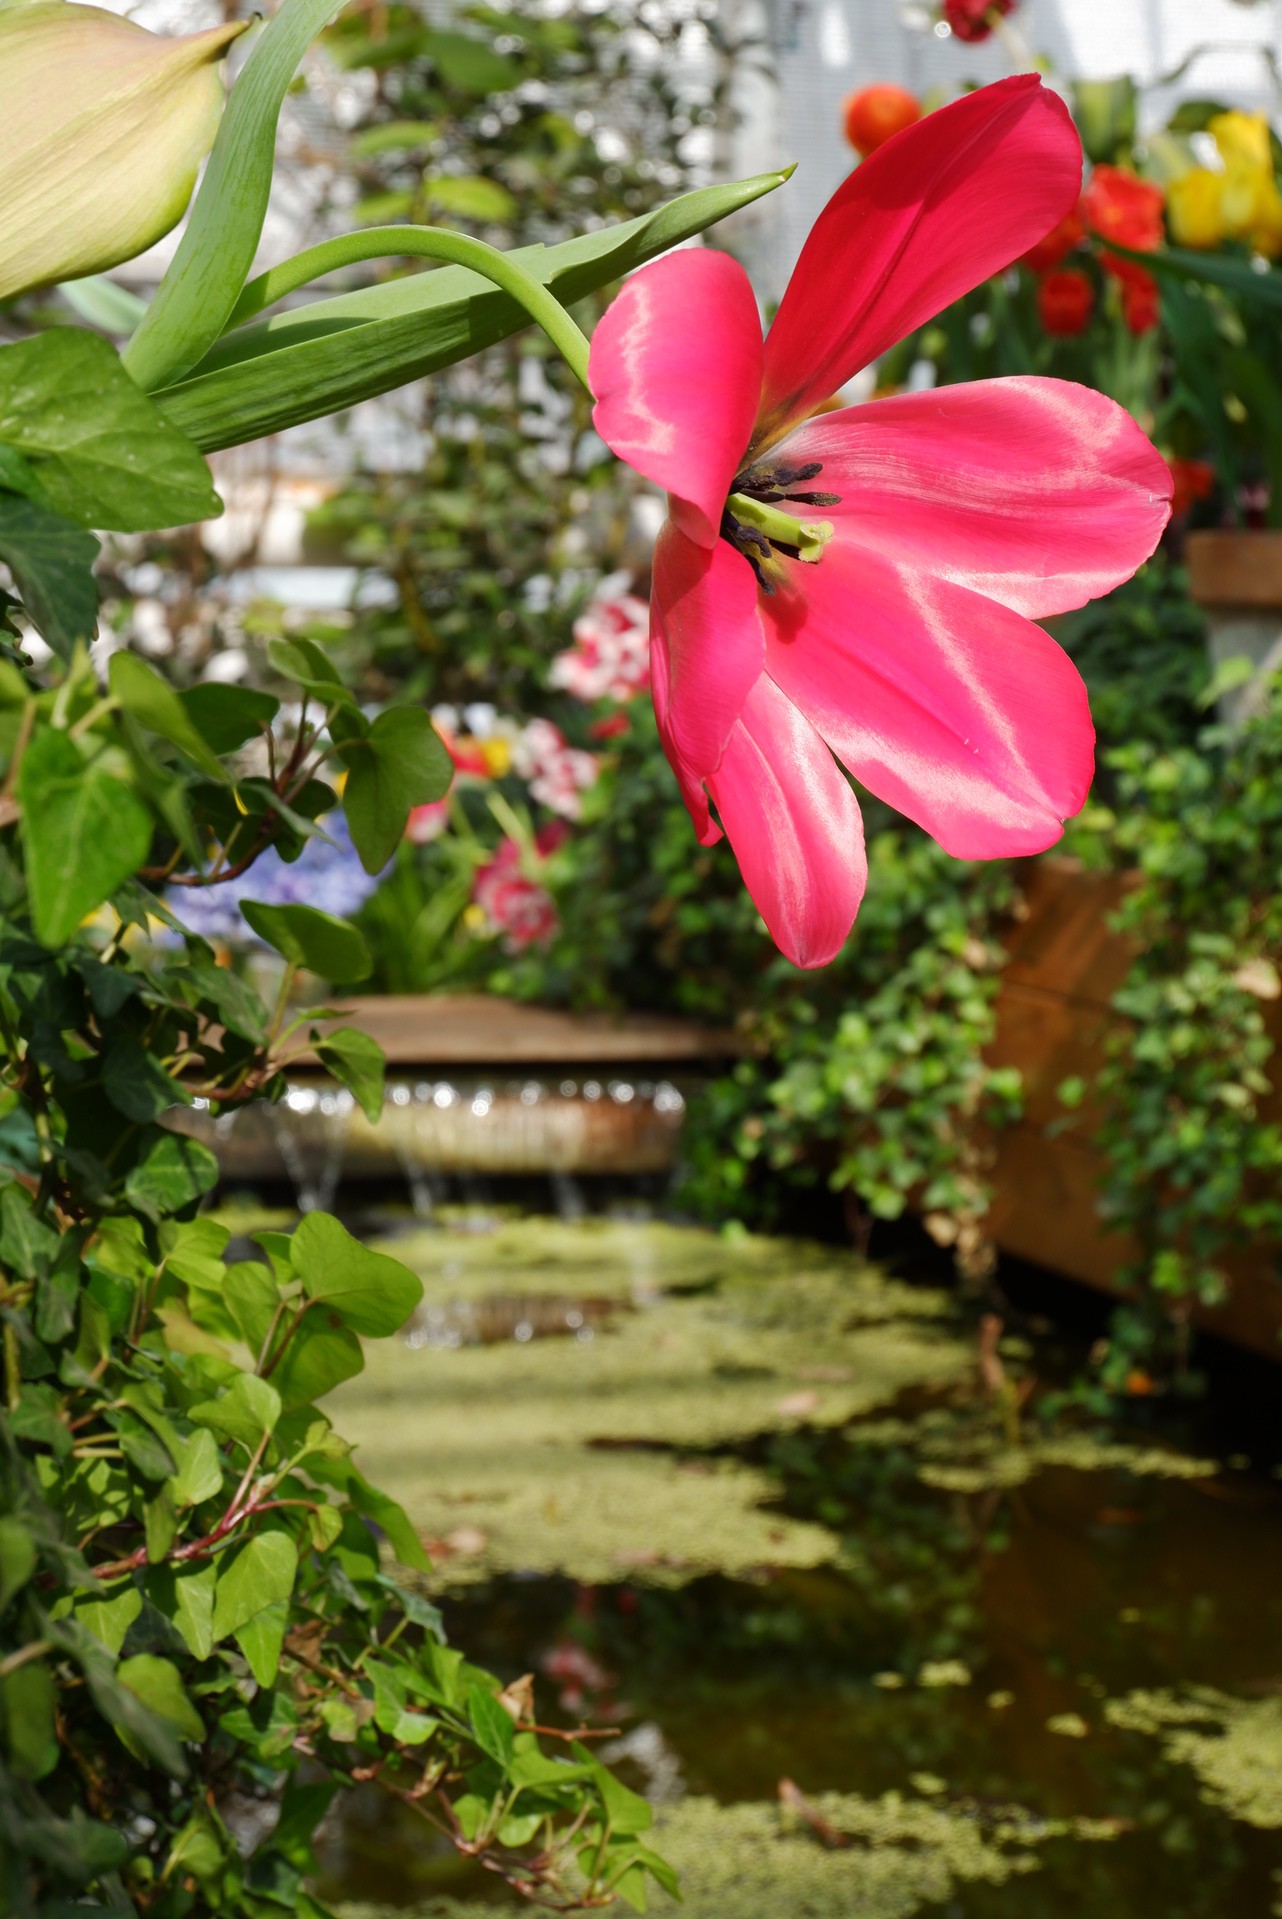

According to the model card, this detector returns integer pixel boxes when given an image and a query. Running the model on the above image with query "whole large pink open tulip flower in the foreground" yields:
[589,75,1171,965]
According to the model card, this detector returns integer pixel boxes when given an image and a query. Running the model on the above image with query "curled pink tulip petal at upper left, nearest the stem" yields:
[587,248,762,547]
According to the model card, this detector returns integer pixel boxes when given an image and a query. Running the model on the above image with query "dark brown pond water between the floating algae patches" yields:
[280,1228,1282,1919]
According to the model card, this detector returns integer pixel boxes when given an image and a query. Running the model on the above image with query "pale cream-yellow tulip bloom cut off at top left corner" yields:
[0,0,244,299]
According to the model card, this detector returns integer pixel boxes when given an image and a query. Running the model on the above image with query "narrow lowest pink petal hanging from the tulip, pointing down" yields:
[710,675,867,967]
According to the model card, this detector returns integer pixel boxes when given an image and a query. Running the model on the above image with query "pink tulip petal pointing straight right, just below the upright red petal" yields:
[779,378,1171,618]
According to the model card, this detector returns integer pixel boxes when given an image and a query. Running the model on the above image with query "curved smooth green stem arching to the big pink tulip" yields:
[225,226,587,386]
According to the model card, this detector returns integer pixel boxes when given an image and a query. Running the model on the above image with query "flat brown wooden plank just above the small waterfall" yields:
[308,992,743,1069]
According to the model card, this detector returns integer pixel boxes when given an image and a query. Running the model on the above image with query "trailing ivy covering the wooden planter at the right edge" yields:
[1059,681,1282,1386]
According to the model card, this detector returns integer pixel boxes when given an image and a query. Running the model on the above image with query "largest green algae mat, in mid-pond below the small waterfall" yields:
[334,1220,973,1589]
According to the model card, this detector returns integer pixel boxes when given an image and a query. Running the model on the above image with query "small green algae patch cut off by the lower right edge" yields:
[1104,1687,1282,1829]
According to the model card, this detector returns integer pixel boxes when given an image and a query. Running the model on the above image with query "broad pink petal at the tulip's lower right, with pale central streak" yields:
[764,535,1094,860]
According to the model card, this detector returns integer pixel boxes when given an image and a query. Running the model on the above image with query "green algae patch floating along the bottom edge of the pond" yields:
[340,1781,1115,1919]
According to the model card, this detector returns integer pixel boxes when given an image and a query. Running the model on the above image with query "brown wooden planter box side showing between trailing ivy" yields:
[988,858,1282,1359]
